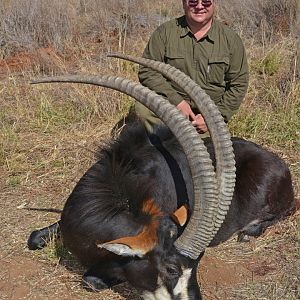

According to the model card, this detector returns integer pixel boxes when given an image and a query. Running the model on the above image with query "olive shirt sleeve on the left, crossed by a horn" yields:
[138,27,183,105]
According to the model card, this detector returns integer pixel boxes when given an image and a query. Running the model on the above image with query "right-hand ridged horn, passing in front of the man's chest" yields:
[108,53,235,252]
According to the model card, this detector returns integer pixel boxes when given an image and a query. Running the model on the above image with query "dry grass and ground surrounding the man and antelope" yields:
[0,0,300,300]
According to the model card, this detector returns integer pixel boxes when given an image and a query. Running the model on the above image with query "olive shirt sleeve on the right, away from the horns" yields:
[218,35,249,122]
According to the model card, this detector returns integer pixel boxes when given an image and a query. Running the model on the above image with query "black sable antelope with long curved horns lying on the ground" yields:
[28,55,295,300]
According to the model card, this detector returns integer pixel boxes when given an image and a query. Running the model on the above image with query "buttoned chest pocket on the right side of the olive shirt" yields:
[207,57,229,85]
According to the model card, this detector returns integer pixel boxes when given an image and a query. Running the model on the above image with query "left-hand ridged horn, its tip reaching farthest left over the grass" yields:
[32,75,217,259]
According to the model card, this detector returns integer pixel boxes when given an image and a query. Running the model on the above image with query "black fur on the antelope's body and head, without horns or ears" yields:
[28,120,295,300]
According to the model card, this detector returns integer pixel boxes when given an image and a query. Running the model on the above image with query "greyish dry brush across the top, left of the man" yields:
[0,0,178,58]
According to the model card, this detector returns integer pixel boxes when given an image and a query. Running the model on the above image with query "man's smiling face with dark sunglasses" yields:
[182,0,215,25]
